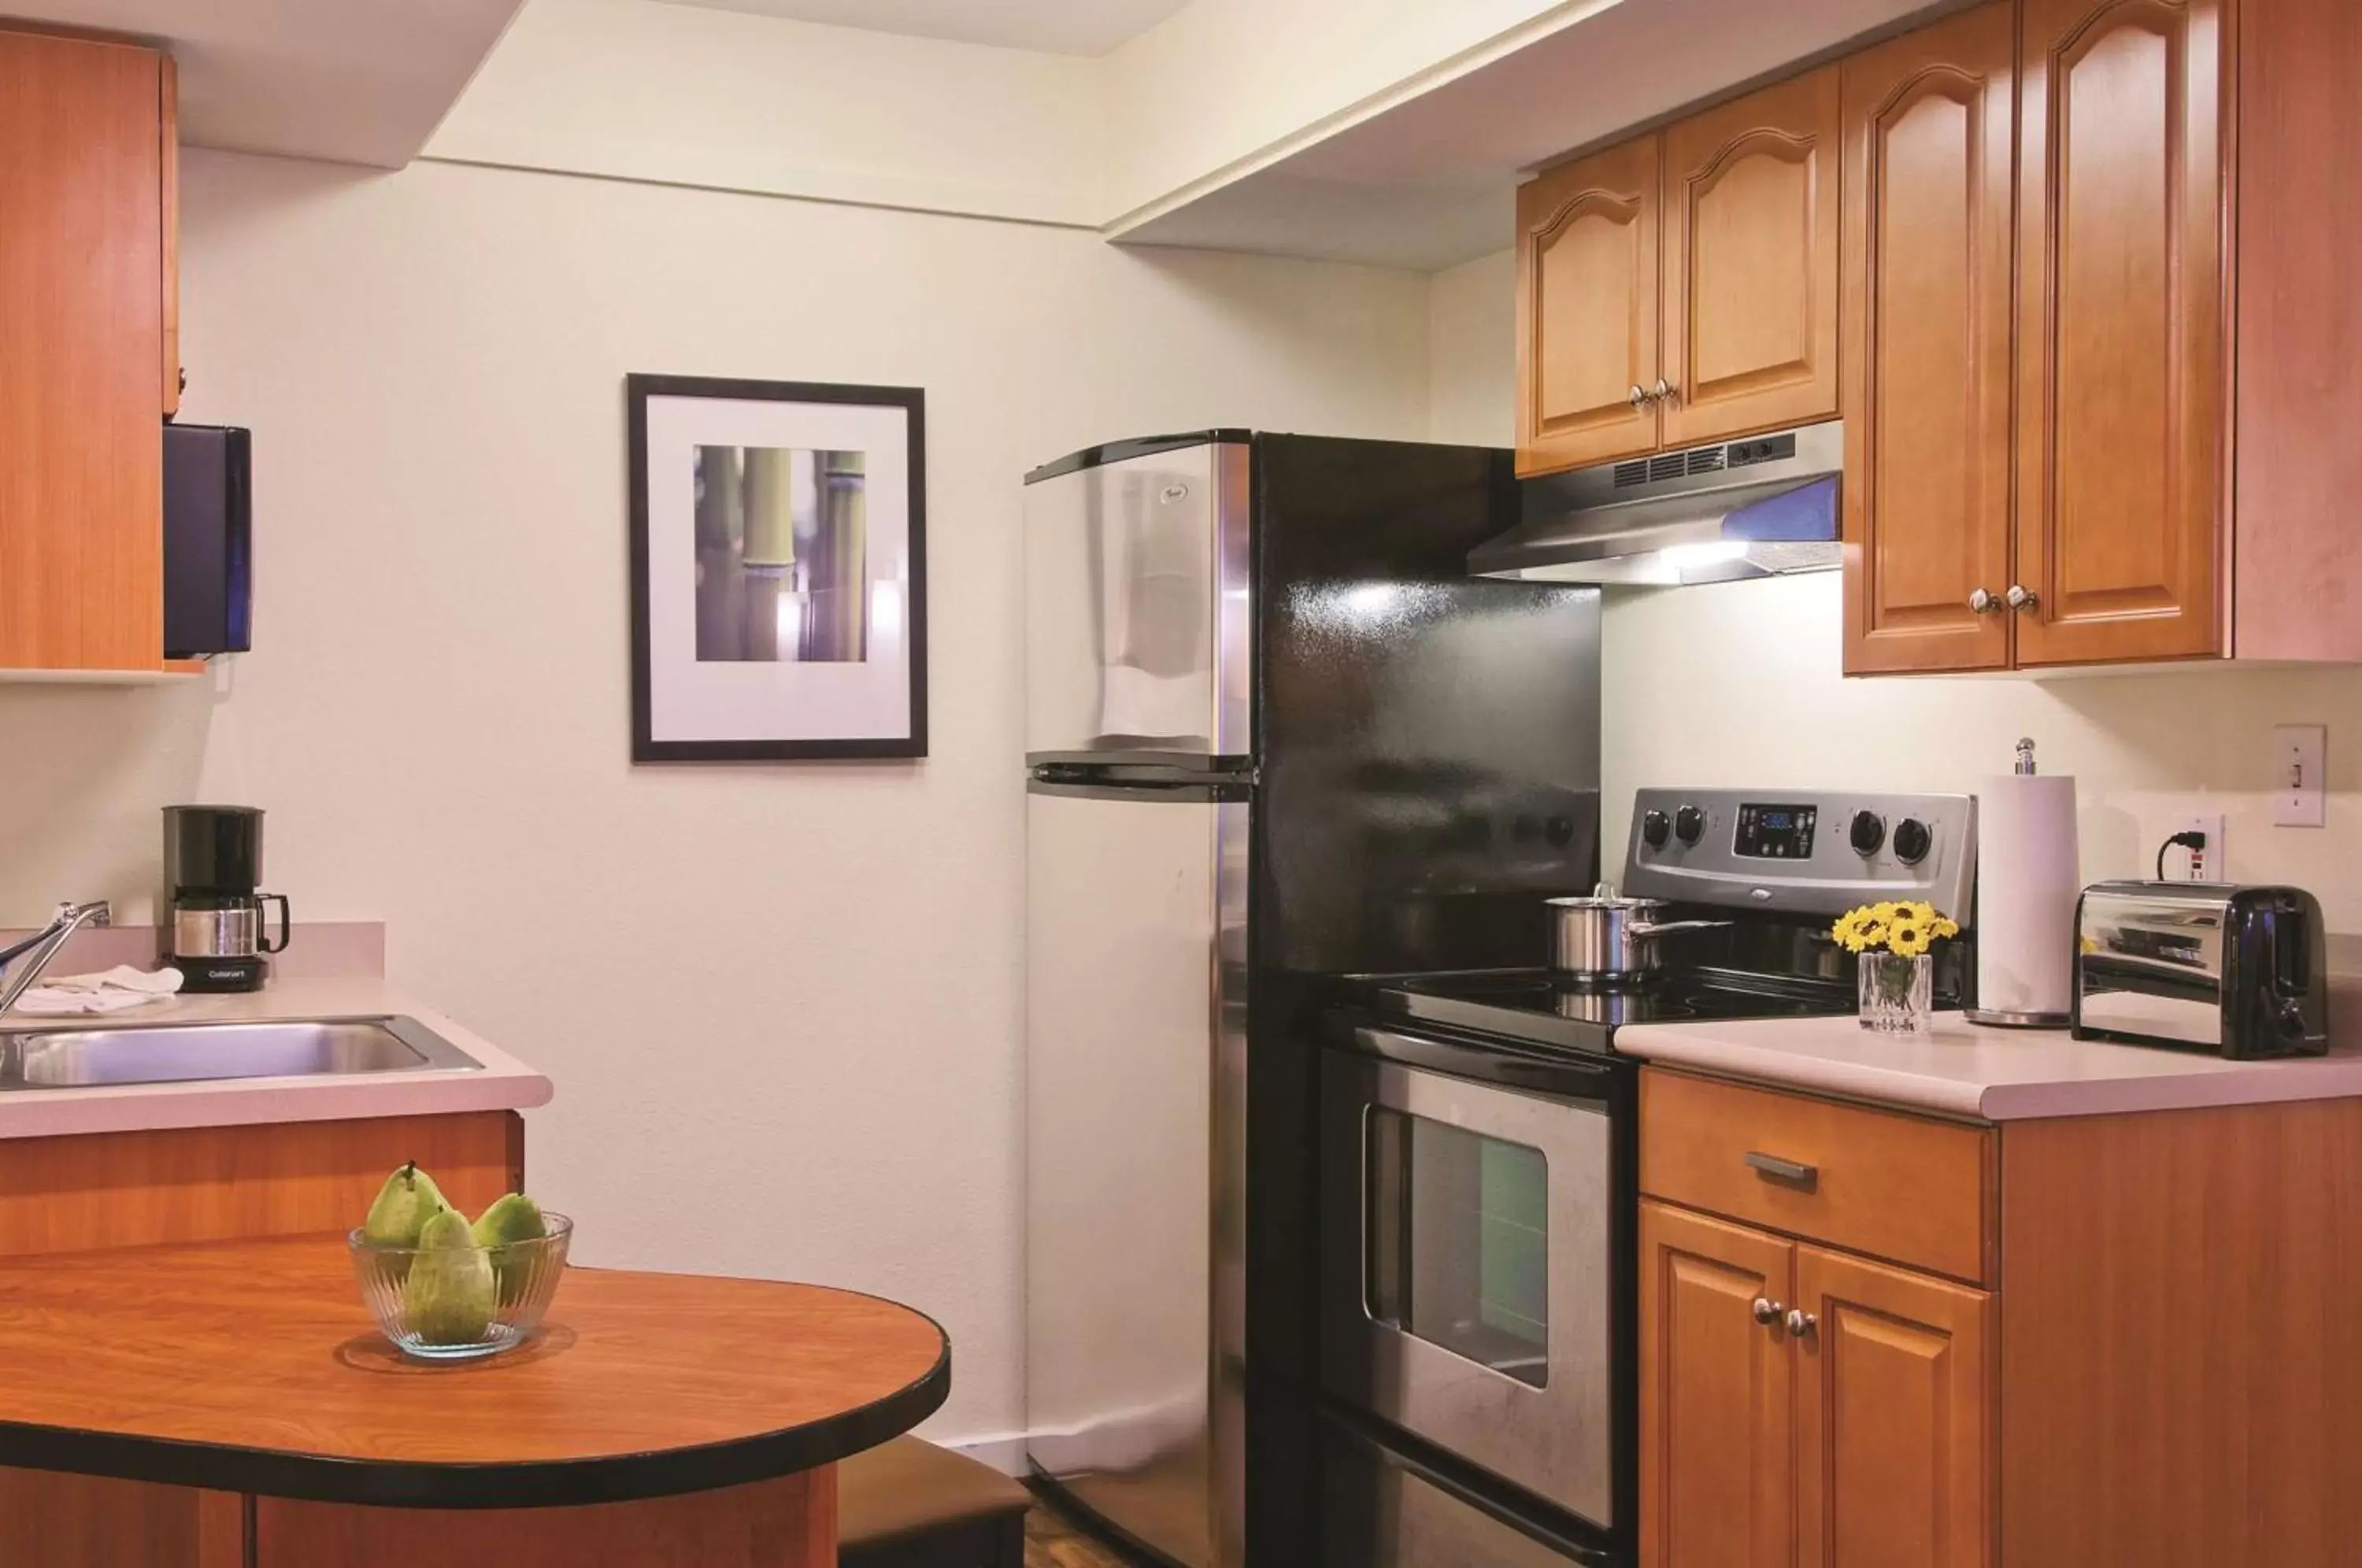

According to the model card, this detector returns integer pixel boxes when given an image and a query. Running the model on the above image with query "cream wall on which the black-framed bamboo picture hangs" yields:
[0,153,1427,1436]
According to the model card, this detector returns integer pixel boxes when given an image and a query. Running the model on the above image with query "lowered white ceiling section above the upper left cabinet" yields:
[0,0,522,168]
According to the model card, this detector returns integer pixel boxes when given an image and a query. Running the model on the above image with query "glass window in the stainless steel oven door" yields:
[1363,1105,1549,1389]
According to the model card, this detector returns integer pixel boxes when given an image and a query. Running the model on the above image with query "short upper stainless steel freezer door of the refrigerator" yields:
[1025,442,1254,763]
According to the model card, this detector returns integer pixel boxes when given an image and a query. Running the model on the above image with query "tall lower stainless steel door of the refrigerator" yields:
[1025,782,1247,1568]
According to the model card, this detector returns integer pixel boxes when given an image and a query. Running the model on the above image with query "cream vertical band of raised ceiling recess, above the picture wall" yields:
[425,0,1623,227]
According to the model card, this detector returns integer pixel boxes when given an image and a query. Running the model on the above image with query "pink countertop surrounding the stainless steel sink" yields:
[0,975,550,1138]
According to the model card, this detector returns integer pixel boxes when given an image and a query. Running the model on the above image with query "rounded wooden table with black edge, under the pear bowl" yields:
[0,1235,952,1568]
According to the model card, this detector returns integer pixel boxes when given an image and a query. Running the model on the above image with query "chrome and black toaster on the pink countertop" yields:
[2074,881,2329,1058]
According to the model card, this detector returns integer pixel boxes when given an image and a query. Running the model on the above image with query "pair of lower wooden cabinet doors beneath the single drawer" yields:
[1639,1200,1994,1568]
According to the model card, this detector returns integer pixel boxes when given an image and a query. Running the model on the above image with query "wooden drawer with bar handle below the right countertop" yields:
[1639,1067,1994,1282]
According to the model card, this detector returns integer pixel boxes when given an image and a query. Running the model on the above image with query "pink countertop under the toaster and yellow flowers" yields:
[1616,982,2362,1122]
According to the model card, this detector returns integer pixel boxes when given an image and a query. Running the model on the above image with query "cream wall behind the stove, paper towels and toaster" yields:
[1429,253,2362,933]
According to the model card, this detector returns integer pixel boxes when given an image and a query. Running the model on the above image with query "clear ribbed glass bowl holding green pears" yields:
[345,1211,574,1360]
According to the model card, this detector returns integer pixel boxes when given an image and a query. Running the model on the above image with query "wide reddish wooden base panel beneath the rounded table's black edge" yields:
[255,1466,836,1568]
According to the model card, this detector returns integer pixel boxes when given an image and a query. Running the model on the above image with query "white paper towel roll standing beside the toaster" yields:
[1977,775,2083,1023]
